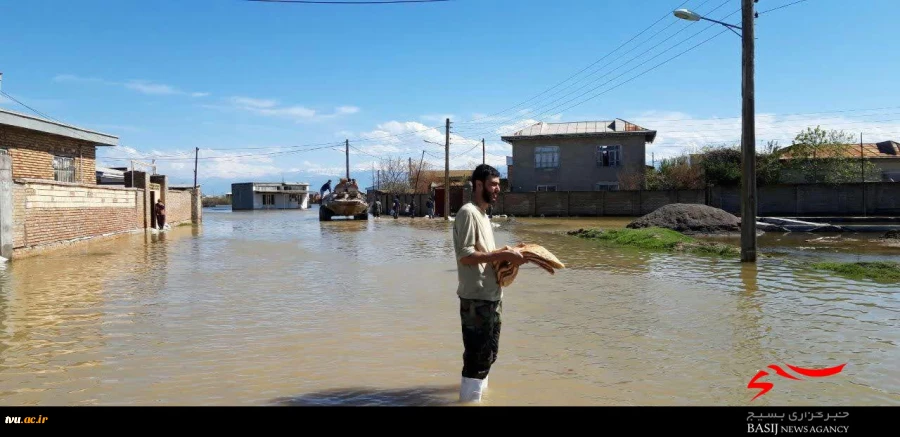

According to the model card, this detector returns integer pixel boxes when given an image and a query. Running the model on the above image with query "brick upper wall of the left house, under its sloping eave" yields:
[0,125,97,184]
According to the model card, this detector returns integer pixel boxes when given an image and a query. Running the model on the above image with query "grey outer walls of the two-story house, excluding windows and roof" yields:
[508,135,646,192]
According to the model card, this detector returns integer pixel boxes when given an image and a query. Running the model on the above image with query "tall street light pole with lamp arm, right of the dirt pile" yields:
[674,0,758,263]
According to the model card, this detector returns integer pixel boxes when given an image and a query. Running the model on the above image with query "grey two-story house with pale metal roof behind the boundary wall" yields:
[501,118,656,192]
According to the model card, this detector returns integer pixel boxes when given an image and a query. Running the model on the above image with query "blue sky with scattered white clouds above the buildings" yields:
[0,0,900,194]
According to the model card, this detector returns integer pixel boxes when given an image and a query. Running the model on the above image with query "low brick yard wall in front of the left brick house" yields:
[13,179,145,252]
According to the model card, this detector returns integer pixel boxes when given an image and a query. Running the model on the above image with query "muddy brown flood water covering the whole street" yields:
[0,206,900,405]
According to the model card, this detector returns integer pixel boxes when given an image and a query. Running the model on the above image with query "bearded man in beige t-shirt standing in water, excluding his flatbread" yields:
[453,164,525,402]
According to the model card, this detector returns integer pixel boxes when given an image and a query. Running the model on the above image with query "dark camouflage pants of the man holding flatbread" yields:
[459,298,503,379]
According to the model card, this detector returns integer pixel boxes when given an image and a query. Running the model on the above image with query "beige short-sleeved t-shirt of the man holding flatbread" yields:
[453,202,503,301]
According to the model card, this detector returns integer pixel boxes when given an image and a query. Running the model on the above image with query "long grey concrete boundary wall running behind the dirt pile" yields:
[493,182,900,217]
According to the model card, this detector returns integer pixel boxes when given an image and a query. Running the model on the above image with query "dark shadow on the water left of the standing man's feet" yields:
[270,385,459,407]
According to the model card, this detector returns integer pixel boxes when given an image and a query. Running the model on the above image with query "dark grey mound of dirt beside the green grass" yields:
[626,203,741,234]
